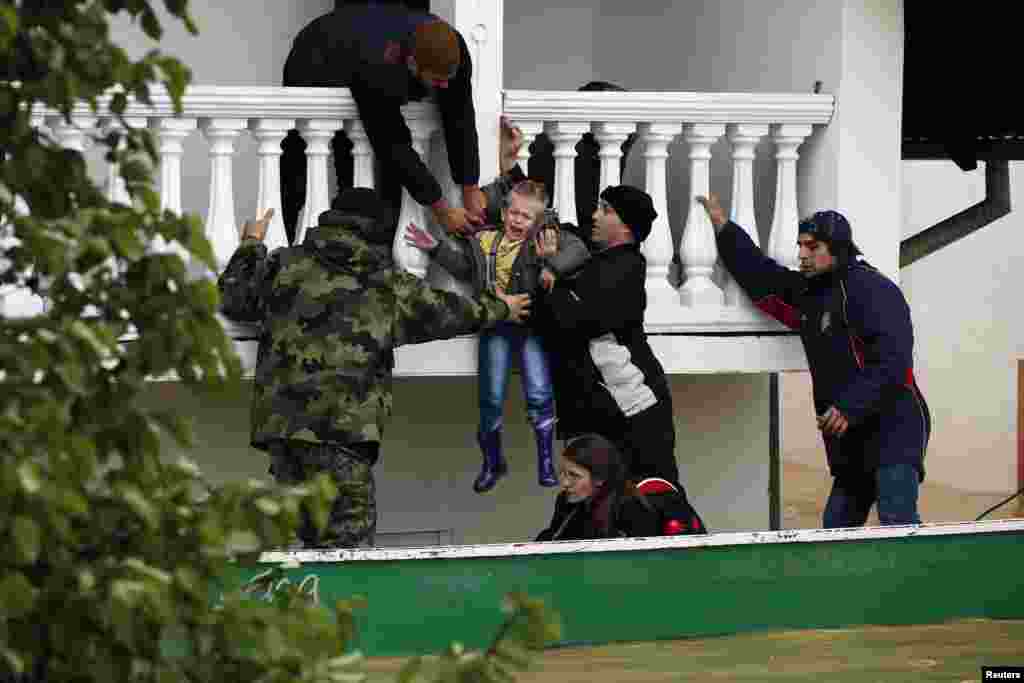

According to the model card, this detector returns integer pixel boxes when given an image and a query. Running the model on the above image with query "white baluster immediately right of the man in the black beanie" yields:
[638,123,683,318]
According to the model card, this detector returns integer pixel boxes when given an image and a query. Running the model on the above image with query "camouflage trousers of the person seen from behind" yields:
[267,440,378,548]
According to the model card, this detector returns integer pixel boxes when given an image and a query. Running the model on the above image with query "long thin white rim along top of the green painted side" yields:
[253,519,1024,563]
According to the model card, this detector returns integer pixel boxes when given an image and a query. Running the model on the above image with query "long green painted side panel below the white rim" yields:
[232,532,1024,655]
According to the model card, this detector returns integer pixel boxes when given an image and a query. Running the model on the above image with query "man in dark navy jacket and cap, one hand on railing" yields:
[697,195,931,528]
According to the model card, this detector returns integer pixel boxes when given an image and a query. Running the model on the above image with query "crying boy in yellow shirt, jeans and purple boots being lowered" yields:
[406,122,588,494]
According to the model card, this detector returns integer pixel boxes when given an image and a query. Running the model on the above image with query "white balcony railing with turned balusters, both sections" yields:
[0,86,834,350]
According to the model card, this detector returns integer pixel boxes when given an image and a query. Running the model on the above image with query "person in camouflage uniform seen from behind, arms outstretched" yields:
[218,192,529,548]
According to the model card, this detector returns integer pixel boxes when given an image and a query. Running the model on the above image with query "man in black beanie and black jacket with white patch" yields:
[537,185,705,532]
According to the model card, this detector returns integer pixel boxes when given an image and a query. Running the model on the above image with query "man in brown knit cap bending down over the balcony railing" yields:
[281,2,484,242]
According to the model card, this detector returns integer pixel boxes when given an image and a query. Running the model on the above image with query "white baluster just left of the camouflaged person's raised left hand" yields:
[200,119,246,271]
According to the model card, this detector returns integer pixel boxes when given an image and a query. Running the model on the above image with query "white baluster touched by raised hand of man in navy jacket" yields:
[679,124,725,306]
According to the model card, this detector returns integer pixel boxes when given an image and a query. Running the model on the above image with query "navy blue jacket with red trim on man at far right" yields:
[717,222,931,478]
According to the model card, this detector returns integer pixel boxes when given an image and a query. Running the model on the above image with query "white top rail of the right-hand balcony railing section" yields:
[505,90,836,125]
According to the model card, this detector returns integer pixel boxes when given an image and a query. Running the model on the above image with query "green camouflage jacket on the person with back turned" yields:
[218,216,508,449]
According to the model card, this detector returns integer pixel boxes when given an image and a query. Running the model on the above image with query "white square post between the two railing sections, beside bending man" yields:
[446,0,505,185]
